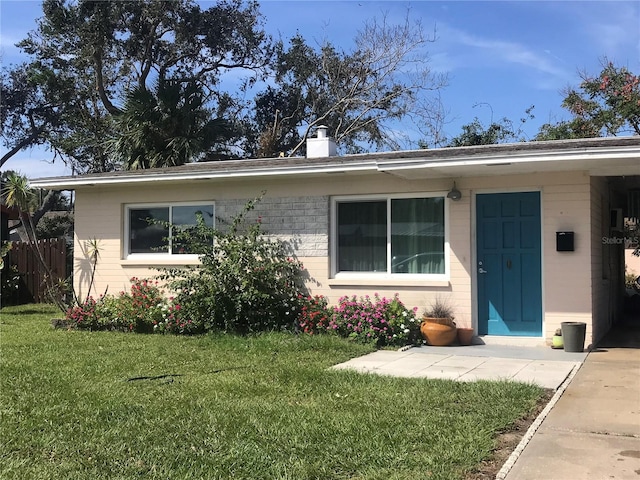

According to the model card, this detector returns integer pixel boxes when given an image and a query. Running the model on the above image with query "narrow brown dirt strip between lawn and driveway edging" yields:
[463,390,554,480]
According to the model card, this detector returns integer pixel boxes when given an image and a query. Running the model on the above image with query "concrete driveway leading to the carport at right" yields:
[498,319,640,480]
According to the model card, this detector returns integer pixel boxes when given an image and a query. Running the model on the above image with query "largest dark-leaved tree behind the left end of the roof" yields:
[3,0,272,172]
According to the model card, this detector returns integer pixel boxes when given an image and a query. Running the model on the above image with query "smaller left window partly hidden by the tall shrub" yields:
[125,204,214,255]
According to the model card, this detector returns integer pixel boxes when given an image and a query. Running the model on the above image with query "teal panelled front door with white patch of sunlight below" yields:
[476,192,542,336]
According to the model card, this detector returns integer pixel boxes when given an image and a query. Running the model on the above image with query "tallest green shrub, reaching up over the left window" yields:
[159,198,304,333]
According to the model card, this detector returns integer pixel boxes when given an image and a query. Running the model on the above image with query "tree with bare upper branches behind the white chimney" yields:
[242,13,446,156]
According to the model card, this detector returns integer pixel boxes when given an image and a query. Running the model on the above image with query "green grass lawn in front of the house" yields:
[0,305,543,480]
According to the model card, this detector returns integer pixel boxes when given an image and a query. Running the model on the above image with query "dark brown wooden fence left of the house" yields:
[5,238,67,303]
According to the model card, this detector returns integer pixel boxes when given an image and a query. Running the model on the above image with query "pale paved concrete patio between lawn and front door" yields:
[333,345,586,390]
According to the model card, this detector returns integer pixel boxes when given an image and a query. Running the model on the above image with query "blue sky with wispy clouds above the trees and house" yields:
[0,0,640,178]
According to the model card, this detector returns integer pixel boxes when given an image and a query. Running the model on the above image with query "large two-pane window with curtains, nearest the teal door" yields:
[333,197,446,276]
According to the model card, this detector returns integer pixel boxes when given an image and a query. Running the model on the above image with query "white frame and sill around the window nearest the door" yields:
[329,191,451,283]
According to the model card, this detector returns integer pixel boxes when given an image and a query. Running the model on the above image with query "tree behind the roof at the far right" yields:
[536,60,640,140]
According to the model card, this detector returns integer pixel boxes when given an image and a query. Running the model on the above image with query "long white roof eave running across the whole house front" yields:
[31,137,640,190]
